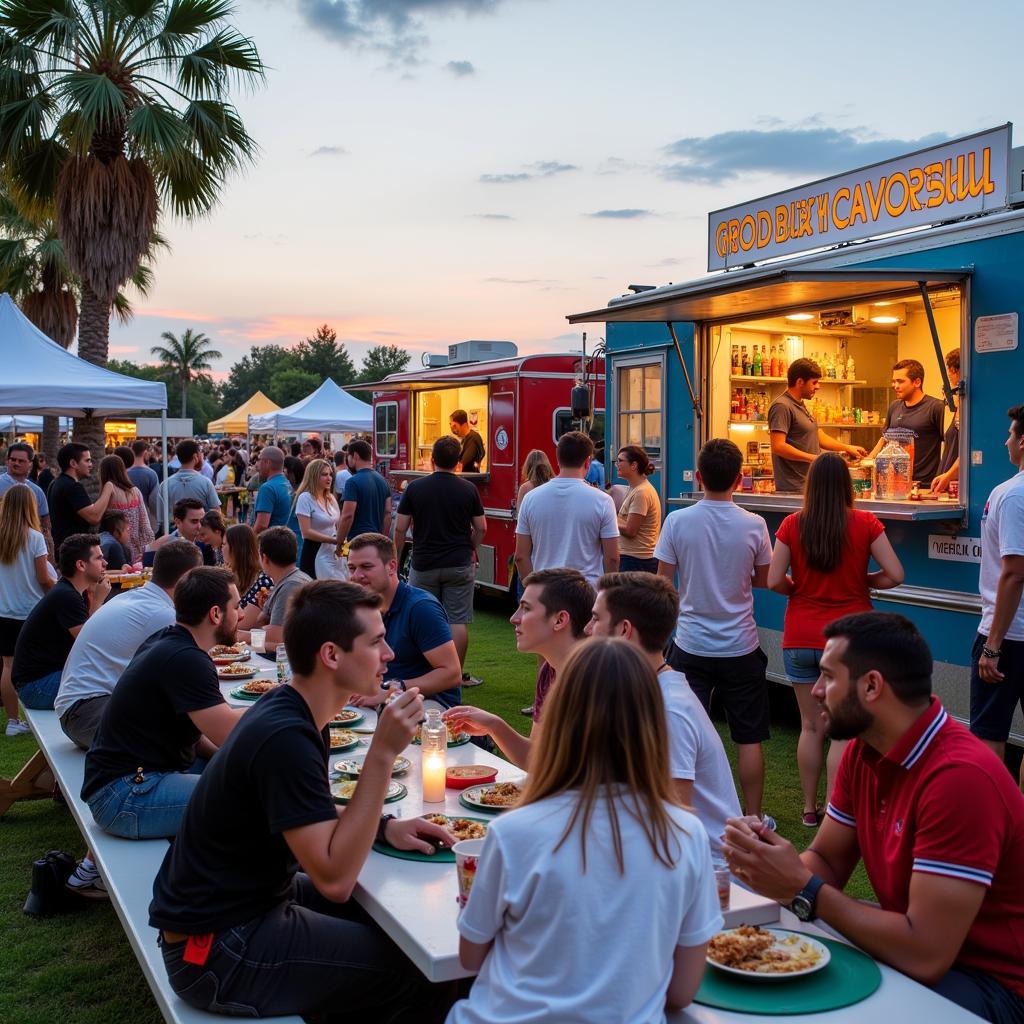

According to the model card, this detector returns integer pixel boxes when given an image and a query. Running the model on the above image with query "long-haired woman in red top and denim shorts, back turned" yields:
[768,452,903,828]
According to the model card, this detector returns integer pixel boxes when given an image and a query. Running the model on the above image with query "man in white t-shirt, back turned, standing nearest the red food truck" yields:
[515,430,618,587]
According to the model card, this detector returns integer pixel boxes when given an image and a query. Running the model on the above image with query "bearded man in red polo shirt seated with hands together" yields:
[725,611,1024,1024]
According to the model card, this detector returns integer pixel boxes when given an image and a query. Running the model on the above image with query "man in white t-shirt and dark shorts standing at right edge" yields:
[971,406,1024,788]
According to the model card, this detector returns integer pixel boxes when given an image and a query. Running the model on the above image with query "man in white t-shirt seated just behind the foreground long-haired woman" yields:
[587,572,739,859]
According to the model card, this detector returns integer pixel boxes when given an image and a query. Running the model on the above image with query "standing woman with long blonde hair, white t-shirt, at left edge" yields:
[0,486,56,736]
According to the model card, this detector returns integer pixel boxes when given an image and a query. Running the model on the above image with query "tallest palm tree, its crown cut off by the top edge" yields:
[0,0,263,450]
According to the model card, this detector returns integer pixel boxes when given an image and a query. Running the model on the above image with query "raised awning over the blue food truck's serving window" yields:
[566,267,972,324]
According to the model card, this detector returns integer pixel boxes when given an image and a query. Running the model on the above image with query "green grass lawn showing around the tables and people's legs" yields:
[0,596,871,1024]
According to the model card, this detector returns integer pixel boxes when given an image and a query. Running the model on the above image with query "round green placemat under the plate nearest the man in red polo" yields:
[693,935,882,1016]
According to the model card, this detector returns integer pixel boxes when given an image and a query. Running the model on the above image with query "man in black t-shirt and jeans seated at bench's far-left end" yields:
[10,534,111,711]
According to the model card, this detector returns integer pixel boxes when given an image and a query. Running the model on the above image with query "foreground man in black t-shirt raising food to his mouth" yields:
[150,580,452,1022]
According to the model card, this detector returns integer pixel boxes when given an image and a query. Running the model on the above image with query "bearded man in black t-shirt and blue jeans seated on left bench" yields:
[82,567,242,839]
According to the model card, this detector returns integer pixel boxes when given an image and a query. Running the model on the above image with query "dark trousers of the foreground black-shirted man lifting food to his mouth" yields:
[160,874,459,1024]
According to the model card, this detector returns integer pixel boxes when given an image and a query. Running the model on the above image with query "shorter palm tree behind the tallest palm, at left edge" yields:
[0,188,160,466]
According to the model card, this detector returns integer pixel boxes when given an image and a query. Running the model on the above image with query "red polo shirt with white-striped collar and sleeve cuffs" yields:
[827,697,1024,996]
